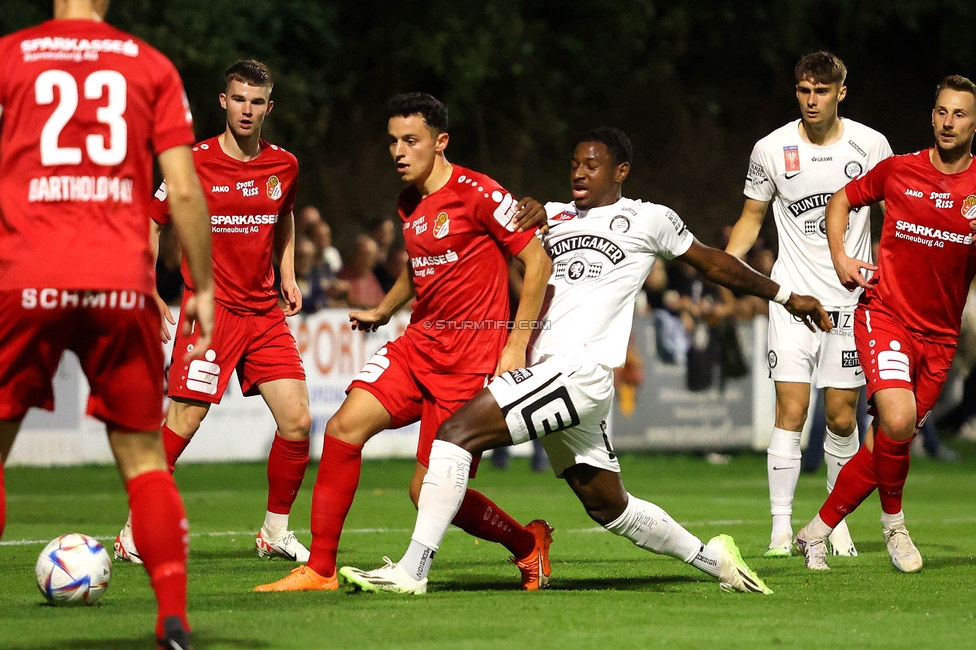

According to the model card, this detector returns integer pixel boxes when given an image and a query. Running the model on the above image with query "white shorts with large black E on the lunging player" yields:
[488,357,620,478]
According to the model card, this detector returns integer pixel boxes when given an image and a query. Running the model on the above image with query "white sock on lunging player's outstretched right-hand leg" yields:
[604,494,721,578]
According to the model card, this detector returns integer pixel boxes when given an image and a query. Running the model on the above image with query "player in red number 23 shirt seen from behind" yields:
[0,0,213,648]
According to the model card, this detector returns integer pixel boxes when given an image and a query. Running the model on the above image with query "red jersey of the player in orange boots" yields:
[397,165,533,374]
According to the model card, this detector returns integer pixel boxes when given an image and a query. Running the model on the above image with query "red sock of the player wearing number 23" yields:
[125,470,190,638]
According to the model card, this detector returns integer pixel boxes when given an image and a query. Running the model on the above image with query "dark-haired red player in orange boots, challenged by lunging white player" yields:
[256,93,552,591]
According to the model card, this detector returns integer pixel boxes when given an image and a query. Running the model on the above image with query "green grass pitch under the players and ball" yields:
[0,447,976,650]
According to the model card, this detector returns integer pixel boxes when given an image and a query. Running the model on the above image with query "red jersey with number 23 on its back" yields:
[0,20,193,293]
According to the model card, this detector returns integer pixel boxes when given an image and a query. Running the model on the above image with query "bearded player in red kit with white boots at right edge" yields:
[796,76,976,573]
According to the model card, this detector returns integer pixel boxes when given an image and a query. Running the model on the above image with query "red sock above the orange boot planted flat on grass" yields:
[308,435,363,576]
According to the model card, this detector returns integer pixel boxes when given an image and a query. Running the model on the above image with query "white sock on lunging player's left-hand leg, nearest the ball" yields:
[398,440,471,580]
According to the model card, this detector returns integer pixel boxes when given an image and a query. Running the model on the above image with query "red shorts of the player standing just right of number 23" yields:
[167,292,305,404]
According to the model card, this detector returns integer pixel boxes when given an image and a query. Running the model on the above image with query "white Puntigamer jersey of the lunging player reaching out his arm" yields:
[530,199,695,368]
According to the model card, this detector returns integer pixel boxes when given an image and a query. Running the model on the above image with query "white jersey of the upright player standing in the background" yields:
[743,119,891,307]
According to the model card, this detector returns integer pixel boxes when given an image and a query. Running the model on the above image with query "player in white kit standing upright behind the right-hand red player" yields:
[726,52,891,557]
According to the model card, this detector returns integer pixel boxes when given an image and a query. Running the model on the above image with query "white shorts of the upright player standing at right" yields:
[766,303,864,388]
